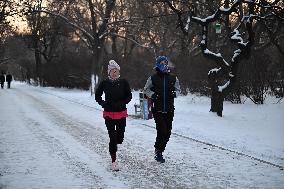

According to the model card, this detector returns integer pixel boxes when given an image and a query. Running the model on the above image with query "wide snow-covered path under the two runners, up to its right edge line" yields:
[0,85,284,189]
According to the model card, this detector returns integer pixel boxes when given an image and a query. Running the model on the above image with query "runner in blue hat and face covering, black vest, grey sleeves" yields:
[144,56,180,163]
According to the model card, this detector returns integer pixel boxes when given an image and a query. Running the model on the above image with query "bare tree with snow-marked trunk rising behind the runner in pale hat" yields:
[23,0,120,94]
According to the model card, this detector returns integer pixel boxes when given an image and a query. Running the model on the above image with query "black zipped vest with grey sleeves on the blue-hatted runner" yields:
[144,71,180,112]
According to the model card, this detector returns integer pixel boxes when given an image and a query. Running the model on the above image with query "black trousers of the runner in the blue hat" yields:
[153,112,174,152]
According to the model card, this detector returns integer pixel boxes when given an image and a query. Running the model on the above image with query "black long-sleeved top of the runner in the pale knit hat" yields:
[95,79,132,112]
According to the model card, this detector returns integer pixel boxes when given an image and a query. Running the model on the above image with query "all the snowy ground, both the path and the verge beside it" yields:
[0,82,284,189]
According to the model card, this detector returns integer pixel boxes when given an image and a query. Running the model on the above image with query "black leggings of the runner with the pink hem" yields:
[105,117,126,154]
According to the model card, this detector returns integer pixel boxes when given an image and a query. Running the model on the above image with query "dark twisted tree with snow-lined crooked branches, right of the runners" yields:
[164,0,283,116]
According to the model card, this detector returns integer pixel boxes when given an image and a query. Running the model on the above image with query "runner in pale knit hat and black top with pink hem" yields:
[95,60,132,171]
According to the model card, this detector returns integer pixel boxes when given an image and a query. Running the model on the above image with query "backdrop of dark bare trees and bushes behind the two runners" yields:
[0,0,284,112]
